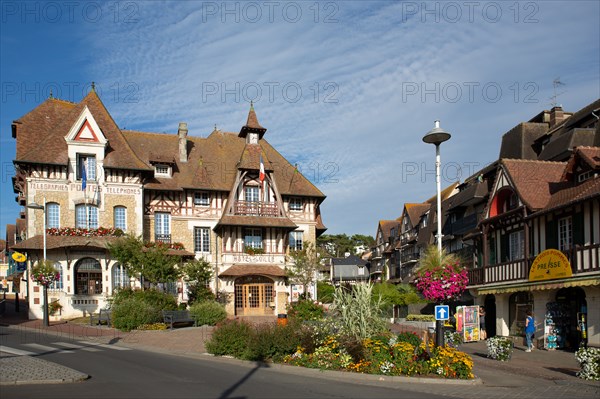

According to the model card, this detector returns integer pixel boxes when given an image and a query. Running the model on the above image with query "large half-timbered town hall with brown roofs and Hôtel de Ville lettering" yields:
[12,90,325,317]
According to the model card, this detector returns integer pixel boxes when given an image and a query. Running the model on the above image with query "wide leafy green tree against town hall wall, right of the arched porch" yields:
[108,234,181,285]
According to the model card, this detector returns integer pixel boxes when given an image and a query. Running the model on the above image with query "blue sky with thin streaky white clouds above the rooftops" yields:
[0,0,600,237]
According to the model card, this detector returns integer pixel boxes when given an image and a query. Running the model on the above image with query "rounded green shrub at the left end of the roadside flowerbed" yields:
[206,320,252,359]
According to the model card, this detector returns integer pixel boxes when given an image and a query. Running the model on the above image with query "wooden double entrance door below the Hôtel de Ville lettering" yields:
[235,276,274,316]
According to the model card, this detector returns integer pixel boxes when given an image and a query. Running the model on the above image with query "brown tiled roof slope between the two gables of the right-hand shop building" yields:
[501,159,567,210]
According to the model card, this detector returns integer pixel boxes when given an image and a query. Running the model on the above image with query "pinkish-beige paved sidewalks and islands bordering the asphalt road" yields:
[0,305,600,399]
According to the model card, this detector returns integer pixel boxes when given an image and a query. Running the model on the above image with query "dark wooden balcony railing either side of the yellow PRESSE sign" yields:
[468,244,600,286]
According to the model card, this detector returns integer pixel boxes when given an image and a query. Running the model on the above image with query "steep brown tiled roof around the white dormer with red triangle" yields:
[15,90,150,170]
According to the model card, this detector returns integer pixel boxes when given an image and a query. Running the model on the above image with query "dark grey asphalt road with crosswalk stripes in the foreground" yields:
[0,333,441,399]
